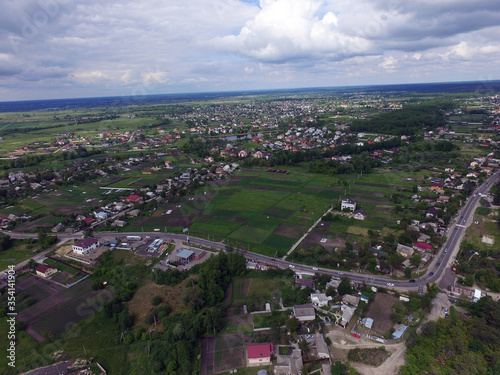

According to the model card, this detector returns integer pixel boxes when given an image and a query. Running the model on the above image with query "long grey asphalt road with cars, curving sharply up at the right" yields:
[1,170,500,290]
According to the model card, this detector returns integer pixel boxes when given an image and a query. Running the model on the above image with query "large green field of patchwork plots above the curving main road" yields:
[131,170,339,256]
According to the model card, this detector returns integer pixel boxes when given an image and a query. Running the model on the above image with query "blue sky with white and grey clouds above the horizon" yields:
[0,0,500,101]
